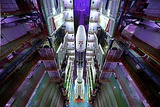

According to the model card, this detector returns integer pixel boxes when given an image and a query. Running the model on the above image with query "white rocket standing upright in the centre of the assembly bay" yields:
[74,25,86,100]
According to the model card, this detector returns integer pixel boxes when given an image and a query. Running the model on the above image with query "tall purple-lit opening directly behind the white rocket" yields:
[74,0,90,79]
